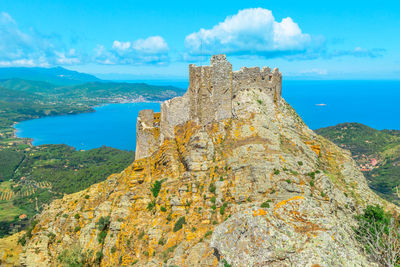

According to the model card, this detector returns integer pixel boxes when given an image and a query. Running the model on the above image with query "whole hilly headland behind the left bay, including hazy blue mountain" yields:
[0,67,184,131]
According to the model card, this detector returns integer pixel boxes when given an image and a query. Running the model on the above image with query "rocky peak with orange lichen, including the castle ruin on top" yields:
[14,55,395,267]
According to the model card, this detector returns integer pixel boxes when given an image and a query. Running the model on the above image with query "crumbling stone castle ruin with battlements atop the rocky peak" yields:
[135,55,282,159]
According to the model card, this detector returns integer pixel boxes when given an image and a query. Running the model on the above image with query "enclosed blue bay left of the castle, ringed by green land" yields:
[15,103,160,150]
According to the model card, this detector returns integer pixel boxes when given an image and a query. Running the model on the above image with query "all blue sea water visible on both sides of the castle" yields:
[16,81,400,150]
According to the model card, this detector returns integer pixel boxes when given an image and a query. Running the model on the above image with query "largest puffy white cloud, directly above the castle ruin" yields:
[185,8,312,56]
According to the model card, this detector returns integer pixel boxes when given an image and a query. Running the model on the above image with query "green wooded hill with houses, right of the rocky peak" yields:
[316,123,400,204]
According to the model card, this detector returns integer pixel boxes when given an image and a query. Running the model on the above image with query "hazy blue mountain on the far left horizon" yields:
[0,67,101,86]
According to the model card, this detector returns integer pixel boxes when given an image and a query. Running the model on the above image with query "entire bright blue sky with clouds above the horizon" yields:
[0,0,400,79]
